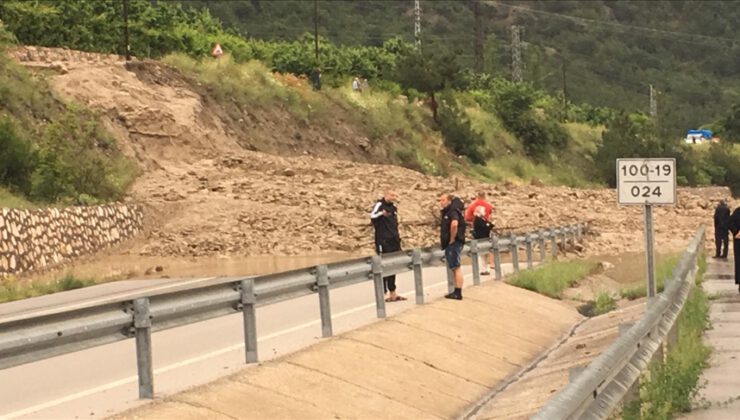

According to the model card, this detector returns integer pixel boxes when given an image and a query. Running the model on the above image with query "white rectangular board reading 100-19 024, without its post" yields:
[617,158,676,205]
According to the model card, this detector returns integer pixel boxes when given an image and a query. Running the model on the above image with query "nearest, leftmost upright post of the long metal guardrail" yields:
[134,298,154,398]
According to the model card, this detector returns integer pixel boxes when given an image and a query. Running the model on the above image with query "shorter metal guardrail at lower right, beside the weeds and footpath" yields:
[533,226,706,420]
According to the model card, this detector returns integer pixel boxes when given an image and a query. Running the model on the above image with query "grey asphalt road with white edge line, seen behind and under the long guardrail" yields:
[0,267,502,419]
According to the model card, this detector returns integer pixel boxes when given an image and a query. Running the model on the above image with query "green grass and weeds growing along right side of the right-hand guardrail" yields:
[622,260,711,420]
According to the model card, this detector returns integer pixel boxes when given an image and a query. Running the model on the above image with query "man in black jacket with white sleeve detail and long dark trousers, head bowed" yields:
[370,191,406,302]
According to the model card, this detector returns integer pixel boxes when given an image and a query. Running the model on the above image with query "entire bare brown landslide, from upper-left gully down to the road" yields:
[7,48,729,256]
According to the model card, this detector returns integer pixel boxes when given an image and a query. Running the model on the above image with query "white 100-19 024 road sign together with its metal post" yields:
[617,158,676,303]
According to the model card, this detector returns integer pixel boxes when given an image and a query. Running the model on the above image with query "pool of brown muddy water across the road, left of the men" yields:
[24,253,362,281]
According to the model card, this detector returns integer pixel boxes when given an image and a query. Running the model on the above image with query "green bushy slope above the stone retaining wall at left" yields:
[0,22,136,207]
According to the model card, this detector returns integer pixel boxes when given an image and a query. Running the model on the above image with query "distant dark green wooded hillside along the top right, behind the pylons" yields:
[184,0,740,138]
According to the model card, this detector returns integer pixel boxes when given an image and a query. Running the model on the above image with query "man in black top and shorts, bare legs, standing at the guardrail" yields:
[439,194,465,300]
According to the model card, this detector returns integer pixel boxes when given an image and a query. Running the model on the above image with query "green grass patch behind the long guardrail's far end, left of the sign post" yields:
[509,261,596,298]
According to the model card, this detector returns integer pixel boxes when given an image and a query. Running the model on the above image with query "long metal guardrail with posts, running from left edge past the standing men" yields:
[0,224,586,398]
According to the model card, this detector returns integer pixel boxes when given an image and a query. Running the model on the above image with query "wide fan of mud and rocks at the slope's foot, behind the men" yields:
[132,152,728,256]
